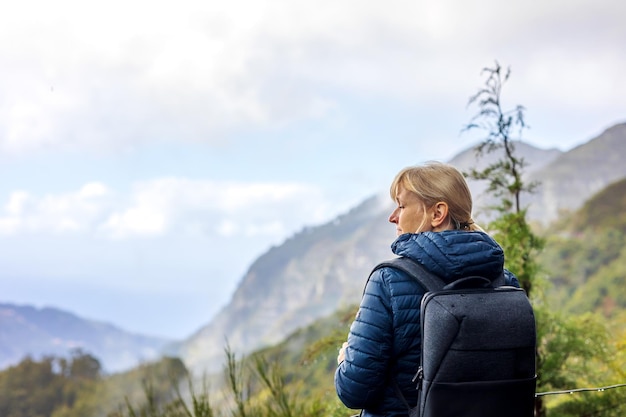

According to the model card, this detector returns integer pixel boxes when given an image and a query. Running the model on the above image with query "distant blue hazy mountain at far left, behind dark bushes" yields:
[0,303,172,372]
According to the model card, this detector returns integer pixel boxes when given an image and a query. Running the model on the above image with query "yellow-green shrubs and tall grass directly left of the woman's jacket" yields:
[110,306,356,417]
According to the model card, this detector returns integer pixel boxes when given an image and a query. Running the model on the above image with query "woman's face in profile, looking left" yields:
[389,186,432,236]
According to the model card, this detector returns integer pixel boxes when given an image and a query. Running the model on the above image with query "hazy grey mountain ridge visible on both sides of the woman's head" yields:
[177,124,626,373]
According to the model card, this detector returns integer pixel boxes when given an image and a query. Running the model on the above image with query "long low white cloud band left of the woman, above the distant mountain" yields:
[0,177,338,243]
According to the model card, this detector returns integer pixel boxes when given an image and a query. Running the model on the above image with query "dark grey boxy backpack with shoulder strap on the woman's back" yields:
[372,257,536,417]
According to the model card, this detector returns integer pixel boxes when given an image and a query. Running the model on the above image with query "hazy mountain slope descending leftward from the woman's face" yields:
[180,197,395,371]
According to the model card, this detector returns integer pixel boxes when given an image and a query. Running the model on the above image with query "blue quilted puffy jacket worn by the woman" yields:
[335,230,519,417]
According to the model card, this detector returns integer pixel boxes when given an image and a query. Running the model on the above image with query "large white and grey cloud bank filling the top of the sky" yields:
[0,0,626,153]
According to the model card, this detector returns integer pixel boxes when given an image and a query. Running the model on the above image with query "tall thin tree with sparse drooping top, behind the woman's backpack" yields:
[463,61,546,417]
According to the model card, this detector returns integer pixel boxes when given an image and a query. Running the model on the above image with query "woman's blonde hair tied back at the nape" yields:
[389,161,482,231]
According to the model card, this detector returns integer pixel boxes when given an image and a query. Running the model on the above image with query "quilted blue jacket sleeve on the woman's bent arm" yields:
[335,269,393,409]
